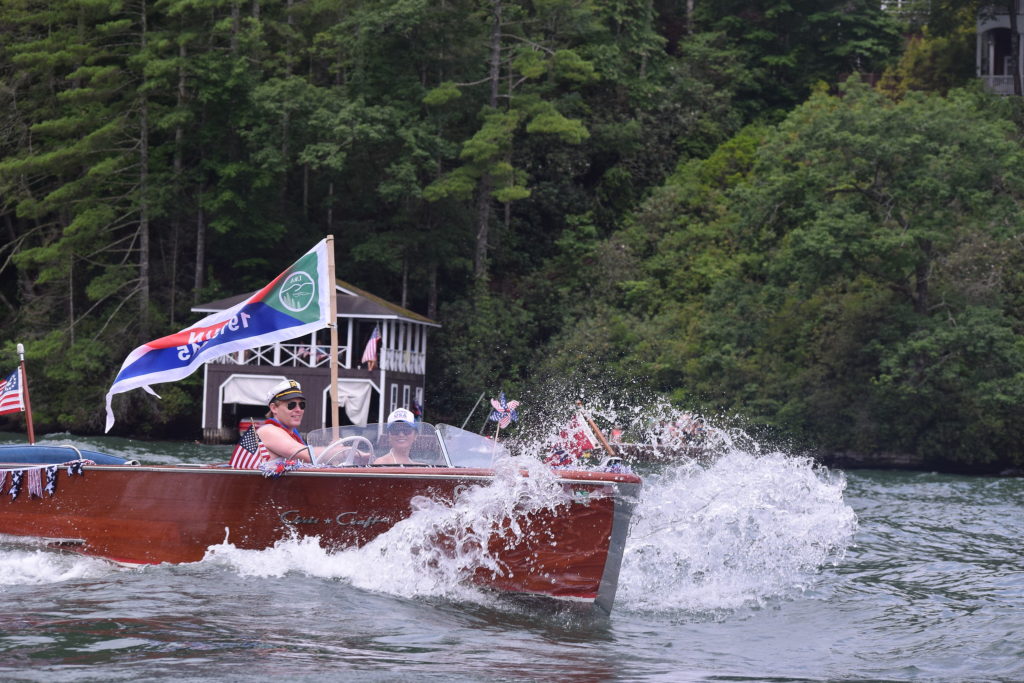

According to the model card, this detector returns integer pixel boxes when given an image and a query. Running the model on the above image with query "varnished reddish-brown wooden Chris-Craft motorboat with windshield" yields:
[0,423,641,611]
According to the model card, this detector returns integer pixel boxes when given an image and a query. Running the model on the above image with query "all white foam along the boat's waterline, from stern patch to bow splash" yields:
[0,405,857,614]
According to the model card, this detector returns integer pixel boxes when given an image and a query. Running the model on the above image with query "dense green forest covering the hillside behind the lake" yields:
[0,0,1024,471]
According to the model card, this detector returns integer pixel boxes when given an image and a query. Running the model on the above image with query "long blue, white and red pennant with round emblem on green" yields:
[106,240,334,431]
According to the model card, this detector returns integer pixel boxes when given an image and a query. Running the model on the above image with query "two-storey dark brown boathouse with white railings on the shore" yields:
[193,280,440,442]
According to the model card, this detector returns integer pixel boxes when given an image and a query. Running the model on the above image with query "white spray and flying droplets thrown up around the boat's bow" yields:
[207,389,857,613]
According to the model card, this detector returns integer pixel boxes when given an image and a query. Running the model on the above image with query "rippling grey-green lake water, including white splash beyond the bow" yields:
[0,435,1024,682]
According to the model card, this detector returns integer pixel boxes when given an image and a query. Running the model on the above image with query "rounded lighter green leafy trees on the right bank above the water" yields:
[548,83,1024,471]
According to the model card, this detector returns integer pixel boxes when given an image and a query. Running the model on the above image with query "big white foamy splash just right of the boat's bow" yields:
[616,450,857,611]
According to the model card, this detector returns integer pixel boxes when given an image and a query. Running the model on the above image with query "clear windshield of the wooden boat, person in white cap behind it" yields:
[306,422,507,468]
